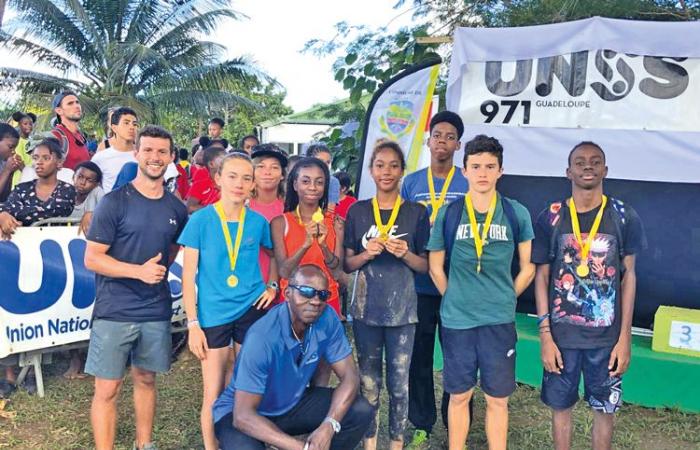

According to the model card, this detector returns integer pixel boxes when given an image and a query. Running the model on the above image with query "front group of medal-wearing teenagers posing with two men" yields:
[0,91,645,450]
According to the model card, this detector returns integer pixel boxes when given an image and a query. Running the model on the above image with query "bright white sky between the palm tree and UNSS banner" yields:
[220,0,411,112]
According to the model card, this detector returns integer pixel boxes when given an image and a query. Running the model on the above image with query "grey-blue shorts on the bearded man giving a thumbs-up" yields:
[85,319,172,380]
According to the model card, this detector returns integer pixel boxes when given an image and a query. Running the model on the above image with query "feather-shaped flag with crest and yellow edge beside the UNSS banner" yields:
[356,60,441,200]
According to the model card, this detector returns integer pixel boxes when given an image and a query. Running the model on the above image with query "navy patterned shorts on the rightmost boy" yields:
[541,347,622,414]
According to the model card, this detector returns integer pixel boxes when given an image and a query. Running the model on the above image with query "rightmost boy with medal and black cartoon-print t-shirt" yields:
[532,142,646,449]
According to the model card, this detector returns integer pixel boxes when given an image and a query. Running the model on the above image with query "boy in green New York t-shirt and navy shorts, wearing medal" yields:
[428,135,535,450]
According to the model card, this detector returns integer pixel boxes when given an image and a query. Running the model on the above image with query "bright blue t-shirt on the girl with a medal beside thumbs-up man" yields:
[178,205,272,328]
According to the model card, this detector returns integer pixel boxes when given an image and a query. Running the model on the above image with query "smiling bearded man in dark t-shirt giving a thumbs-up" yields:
[85,126,187,450]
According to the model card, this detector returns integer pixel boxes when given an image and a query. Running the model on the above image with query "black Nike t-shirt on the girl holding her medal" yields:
[343,199,430,327]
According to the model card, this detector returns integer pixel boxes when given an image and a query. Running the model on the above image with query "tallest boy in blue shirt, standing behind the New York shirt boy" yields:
[401,111,467,449]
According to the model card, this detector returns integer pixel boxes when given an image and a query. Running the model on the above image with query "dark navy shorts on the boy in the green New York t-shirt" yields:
[440,323,518,398]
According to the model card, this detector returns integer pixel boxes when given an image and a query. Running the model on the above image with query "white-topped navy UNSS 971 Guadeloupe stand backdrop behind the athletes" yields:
[447,18,700,326]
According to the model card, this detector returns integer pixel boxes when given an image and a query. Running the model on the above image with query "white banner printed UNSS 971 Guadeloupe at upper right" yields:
[447,18,700,183]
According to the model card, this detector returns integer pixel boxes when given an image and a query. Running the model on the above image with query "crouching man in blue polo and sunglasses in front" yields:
[214,265,374,450]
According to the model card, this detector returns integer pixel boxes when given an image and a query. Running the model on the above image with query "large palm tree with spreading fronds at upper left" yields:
[0,0,274,120]
